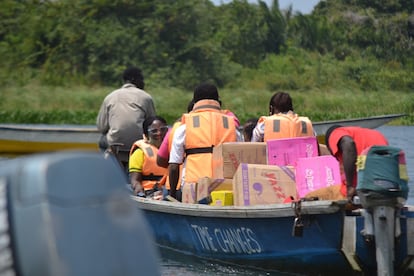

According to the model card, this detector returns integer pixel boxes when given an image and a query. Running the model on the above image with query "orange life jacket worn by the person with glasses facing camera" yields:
[129,140,168,191]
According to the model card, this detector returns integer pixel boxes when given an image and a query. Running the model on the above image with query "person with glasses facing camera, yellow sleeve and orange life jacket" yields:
[129,116,168,196]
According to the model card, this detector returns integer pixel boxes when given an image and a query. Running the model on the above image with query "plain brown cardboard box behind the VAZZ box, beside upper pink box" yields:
[213,142,267,179]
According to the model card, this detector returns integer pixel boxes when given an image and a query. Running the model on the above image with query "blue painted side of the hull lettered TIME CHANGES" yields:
[134,198,352,274]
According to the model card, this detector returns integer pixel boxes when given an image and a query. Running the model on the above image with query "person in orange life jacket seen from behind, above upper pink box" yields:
[251,91,316,142]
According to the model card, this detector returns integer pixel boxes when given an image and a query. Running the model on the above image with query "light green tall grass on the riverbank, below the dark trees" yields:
[0,48,414,125]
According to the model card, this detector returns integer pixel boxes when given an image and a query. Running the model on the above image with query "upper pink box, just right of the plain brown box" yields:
[266,136,319,166]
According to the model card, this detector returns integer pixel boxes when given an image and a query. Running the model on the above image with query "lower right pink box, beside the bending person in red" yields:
[295,155,341,198]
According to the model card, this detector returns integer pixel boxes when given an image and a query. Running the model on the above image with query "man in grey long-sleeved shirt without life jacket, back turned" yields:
[96,67,155,170]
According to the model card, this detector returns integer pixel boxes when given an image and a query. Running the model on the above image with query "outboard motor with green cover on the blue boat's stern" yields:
[356,146,408,276]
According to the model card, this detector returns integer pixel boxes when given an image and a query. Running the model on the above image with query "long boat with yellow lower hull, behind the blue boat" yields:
[0,114,404,156]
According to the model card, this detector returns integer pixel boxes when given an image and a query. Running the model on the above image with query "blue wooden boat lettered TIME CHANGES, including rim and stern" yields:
[132,197,414,275]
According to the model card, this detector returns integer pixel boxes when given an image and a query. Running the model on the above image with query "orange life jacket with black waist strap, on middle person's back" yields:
[184,100,236,182]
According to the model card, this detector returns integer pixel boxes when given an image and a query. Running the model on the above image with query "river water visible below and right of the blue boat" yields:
[161,126,414,276]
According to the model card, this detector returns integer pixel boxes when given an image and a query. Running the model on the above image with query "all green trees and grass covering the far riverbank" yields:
[0,0,414,125]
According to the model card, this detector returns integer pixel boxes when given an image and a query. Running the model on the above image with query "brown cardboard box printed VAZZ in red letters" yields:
[233,163,297,206]
